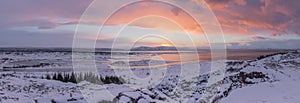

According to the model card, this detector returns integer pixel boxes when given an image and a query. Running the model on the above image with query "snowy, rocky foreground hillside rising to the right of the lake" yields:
[0,51,300,103]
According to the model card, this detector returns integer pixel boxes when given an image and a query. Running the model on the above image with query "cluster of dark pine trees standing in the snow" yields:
[42,72,125,84]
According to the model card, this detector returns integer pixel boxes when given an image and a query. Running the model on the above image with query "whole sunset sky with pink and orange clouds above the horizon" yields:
[0,0,300,49]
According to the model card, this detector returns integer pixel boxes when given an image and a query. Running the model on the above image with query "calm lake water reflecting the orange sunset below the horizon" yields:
[109,50,284,68]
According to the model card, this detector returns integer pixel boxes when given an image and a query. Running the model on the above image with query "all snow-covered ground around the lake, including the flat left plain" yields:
[0,51,300,103]
